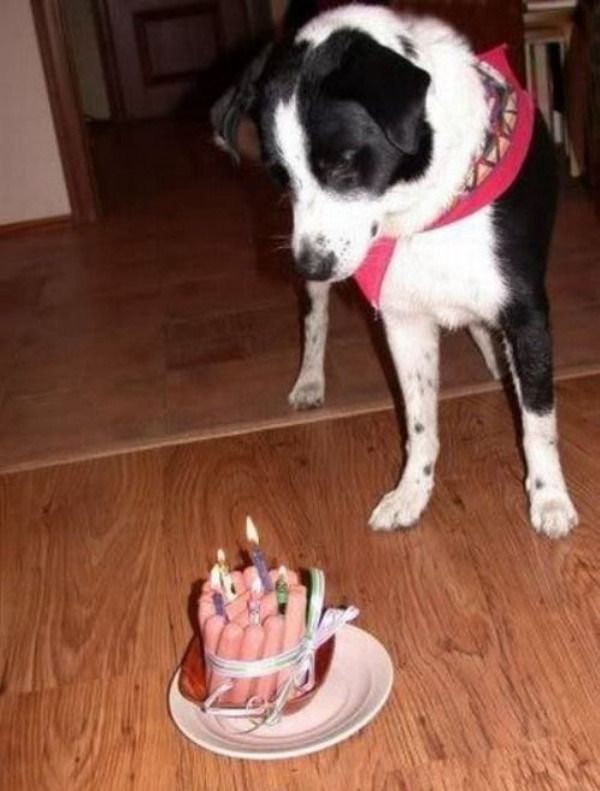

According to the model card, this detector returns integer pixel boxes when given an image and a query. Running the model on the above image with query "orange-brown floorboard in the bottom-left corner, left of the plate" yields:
[0,671,178,791]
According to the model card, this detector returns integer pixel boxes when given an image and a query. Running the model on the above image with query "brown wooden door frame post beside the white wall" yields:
[31,0,100,225]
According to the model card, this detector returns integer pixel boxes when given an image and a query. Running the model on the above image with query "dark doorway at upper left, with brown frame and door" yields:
[33,0,273,224]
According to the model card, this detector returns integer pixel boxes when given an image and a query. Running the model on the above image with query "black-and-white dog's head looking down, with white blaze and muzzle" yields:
[257,7,432,280]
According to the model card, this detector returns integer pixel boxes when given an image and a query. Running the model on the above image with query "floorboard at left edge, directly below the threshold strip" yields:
[0,453,175,693]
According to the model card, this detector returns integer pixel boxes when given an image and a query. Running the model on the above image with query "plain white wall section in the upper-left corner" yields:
[0,0,71,225]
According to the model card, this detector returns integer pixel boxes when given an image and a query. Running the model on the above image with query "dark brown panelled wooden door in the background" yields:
[101,0,271,119]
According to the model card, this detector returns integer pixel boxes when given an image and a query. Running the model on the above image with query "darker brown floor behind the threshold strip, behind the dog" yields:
[0,123,600,470]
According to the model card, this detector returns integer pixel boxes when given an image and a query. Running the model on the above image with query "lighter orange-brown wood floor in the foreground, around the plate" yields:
[0,376,600,791]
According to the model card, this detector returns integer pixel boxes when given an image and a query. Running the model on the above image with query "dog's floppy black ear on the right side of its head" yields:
[322,31,430,154]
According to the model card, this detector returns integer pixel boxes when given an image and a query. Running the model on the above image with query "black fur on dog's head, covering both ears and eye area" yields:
[258,28,432,195]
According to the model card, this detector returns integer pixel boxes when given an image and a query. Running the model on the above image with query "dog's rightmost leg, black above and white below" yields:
[504,308,577,538]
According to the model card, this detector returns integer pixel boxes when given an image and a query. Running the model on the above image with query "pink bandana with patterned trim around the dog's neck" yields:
[354,45,534,309]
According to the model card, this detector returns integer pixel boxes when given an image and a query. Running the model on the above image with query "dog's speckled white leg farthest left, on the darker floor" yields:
[288,280,331,409]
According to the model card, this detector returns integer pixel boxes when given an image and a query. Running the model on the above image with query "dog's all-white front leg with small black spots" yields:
[369,315,439,530]
